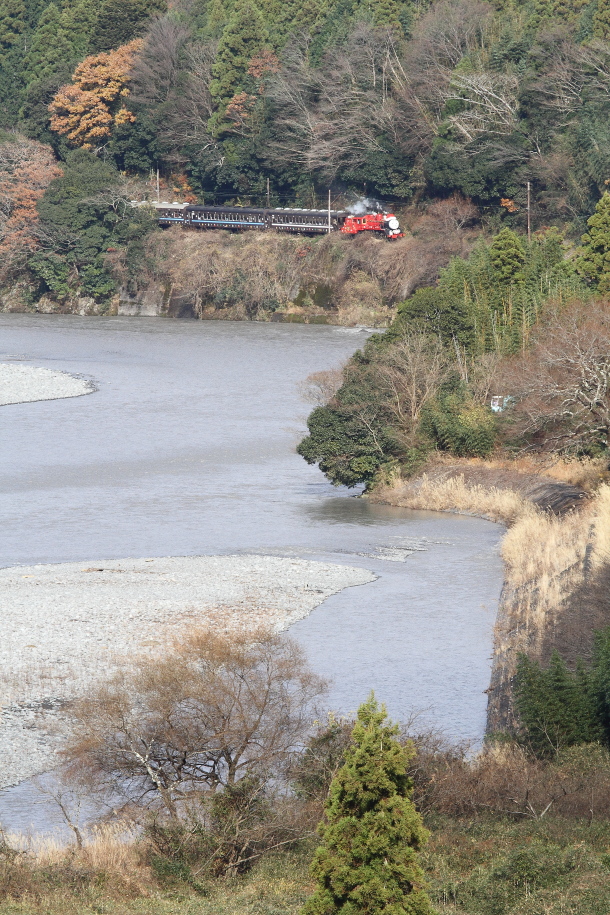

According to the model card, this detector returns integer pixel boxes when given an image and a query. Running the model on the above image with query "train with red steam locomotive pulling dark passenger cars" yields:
[155,203,404,240]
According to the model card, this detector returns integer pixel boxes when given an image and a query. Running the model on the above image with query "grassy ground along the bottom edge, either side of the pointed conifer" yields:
[0,816,610,915]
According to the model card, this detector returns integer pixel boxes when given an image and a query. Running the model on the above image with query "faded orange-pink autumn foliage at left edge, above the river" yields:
[0,134,62,281]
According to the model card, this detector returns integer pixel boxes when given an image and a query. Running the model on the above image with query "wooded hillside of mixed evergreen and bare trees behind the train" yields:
[0,0,610,304]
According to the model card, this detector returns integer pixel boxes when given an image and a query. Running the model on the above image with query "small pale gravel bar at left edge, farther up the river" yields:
[0,362,95,406]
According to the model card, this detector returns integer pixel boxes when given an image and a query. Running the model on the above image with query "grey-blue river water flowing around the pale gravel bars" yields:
[0,315,502,828]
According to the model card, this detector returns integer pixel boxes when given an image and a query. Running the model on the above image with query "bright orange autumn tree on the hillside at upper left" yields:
[49,39,142,149]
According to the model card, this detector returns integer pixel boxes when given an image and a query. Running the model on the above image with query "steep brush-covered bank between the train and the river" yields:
[0,214,475,327]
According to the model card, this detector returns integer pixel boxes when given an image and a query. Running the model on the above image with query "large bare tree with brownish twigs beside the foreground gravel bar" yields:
[66,630,325,819]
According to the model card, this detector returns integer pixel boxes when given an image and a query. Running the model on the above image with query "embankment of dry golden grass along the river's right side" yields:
[369,460,610,734]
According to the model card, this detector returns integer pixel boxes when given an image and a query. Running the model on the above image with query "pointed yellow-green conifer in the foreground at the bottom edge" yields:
[303,694,432,915]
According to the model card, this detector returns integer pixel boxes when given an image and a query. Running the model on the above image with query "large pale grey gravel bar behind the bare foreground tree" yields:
[0,556,375,787]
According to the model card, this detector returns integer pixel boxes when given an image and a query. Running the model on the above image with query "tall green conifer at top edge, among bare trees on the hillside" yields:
[209,0,269,136]
